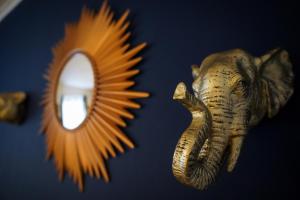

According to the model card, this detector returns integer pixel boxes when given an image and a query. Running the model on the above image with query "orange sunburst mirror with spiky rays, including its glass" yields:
[42,1,149,191]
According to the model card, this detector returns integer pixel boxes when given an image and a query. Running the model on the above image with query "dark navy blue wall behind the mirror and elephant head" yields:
[0,0,300,200]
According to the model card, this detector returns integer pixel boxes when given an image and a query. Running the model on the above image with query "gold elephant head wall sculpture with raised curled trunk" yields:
[172,49,293,190]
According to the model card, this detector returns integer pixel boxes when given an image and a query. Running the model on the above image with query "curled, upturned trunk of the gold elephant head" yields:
[172,83,229,190]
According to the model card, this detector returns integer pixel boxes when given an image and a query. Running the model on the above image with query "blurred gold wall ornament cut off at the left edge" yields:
[0,92,26,123]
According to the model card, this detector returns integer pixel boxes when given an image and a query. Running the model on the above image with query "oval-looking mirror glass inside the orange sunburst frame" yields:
[56,53,94,130]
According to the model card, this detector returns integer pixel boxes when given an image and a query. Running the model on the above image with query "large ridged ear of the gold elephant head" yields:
[259,48,294,117]
